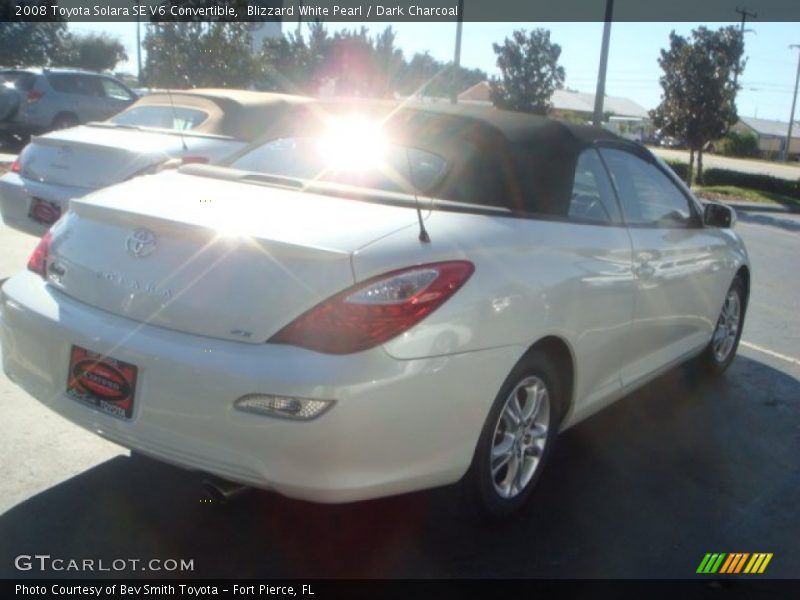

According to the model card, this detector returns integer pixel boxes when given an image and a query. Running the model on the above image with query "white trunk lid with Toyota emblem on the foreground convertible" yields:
[49,172,416,343]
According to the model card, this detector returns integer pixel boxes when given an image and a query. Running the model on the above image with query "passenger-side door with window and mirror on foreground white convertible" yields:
[600,145,729,386]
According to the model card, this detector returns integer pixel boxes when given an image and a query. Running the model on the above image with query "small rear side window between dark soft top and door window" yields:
[568,148,622,223]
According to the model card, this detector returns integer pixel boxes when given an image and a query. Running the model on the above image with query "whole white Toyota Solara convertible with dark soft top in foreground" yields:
[0,104,750,515]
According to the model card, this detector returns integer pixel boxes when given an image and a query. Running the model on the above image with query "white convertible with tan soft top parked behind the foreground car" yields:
[0,89,309,235]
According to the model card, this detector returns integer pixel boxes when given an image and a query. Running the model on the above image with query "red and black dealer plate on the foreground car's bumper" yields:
[67,346,137,419]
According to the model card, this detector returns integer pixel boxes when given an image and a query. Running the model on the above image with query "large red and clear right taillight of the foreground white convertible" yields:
[269,260,475,354]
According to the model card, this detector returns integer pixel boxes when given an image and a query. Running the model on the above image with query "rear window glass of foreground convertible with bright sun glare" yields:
[230,135,446,192]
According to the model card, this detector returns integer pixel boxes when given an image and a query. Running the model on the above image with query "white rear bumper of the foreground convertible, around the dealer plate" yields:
[0,272,522,502]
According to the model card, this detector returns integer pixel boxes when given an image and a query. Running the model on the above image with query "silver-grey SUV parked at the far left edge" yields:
[0,68,136,142]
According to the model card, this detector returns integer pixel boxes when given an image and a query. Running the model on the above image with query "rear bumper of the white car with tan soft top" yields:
[0,173,92,236]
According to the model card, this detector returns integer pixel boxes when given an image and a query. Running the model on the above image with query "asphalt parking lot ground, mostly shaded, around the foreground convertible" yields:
[0,213,800,578]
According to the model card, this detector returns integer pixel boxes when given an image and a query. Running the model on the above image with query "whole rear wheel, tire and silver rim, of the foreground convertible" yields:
[466,352,562,517]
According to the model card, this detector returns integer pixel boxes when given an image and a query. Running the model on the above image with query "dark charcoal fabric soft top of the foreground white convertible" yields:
[236,100,636,216]
